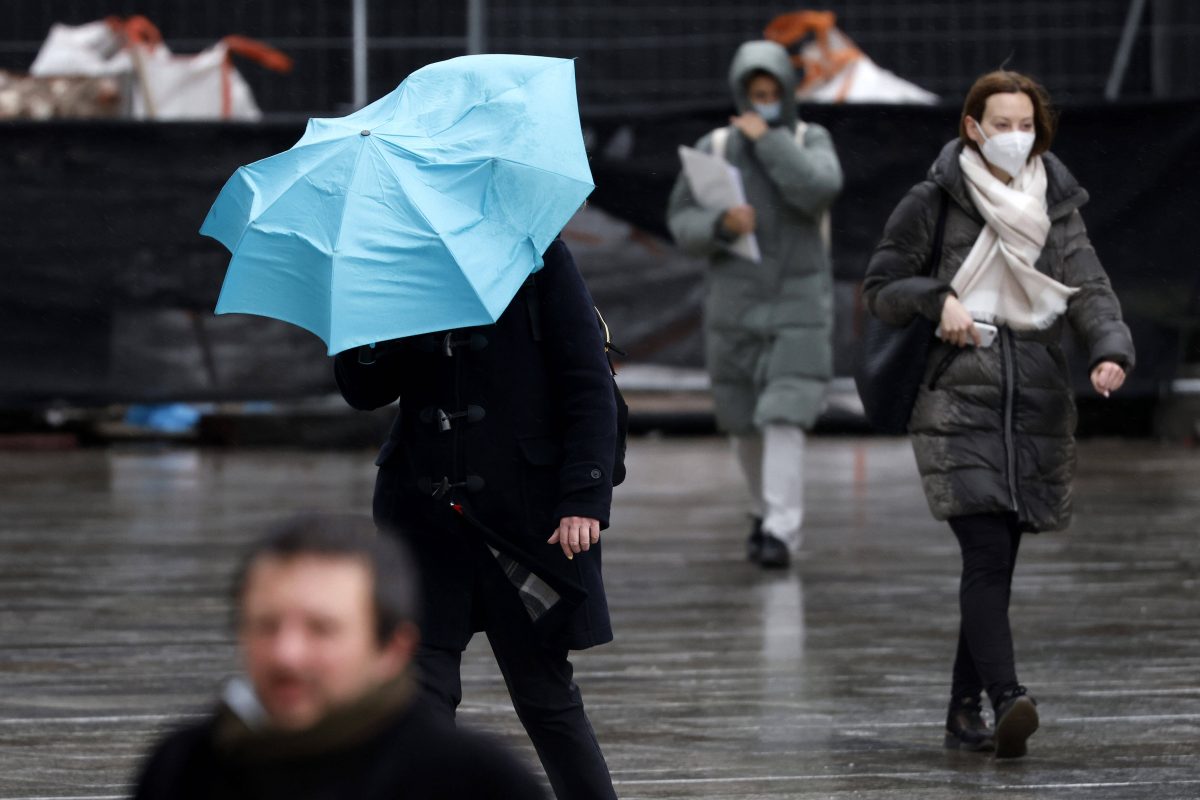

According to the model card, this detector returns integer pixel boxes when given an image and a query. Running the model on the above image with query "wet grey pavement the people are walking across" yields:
[0,438,1200,800]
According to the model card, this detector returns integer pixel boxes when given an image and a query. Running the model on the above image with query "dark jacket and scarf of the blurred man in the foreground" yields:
[134,680,546,800]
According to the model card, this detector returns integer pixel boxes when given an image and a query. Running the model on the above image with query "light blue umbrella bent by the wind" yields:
[200,55,594,355]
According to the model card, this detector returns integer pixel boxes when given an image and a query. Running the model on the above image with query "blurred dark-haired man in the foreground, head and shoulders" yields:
[136,516,545,800]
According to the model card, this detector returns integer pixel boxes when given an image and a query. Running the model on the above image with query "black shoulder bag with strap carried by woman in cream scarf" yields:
[854,191,947,434]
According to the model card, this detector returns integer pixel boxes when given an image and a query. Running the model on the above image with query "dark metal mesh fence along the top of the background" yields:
[0,0,1200,115]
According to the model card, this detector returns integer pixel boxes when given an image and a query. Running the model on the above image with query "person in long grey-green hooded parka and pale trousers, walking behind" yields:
[667,41,841,566]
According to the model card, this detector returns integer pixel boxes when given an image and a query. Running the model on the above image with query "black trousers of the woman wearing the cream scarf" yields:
[949,513,1021,708]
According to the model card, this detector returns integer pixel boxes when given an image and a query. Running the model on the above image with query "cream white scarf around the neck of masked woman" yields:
[950,148,1079,331]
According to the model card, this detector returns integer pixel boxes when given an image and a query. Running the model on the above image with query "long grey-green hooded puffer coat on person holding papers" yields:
[667,42,842,434]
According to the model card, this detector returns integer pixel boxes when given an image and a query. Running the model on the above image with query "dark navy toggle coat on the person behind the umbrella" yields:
[335,240,617,649]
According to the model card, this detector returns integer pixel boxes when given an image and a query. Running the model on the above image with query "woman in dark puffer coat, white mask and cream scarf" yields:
[864,72,1134,757]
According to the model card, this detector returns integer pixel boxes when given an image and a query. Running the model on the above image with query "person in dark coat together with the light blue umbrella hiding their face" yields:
[203,55,617,800]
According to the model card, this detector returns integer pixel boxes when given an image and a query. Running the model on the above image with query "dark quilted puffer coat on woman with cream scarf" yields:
[863,140,1134,531]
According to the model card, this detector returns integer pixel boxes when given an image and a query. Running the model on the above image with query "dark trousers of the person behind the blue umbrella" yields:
[416,543,617,800]
